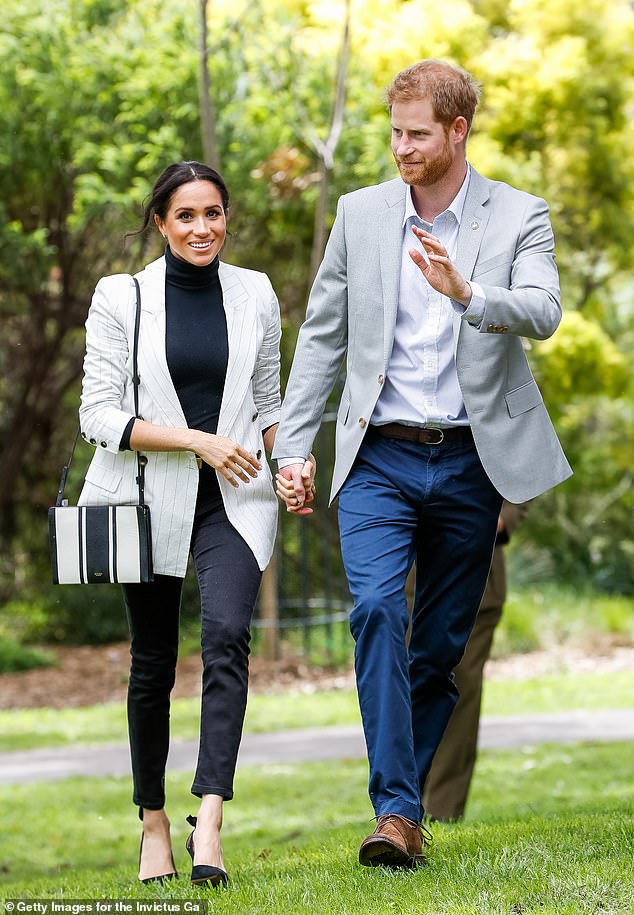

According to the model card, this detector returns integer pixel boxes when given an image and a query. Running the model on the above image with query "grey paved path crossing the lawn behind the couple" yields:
[0,709,634,785]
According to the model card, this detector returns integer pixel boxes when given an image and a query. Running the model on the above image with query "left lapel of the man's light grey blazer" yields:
[379,179,405,366]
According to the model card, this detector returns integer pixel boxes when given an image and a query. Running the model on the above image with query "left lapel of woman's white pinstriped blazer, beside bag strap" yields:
[137,257,187,426]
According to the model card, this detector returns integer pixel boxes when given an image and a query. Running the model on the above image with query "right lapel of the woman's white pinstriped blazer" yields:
[218,261,256,435]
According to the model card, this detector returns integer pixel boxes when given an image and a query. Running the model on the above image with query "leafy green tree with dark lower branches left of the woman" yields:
[0,0,199,616]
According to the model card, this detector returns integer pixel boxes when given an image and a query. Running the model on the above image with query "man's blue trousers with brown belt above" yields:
[339,430,502,822]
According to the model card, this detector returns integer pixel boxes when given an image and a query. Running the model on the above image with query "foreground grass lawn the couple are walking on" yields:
[0,743,634,915]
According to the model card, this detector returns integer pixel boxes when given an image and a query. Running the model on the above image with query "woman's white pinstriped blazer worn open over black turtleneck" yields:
[79,257,280,577]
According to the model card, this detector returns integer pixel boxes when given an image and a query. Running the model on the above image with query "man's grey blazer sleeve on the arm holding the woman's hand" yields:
[273,197,348,458]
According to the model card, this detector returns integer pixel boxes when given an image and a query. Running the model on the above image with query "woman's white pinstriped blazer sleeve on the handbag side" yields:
[79,274,134,452]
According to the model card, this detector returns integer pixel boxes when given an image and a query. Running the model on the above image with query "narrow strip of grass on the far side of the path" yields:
[0,671,634,752]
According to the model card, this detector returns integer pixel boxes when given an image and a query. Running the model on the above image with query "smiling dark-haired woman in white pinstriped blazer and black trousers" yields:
[80,162,313,886]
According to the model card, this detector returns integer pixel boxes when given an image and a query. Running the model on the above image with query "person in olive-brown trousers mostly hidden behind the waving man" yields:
[422,502,527,823]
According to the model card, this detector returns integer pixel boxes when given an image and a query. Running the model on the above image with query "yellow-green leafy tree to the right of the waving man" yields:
[464,0,634,590]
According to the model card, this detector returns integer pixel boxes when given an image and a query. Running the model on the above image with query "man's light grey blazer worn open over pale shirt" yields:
[273,169,572,502]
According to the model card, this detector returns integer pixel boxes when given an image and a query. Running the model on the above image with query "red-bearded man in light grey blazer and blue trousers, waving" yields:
[273,60,571,866]
